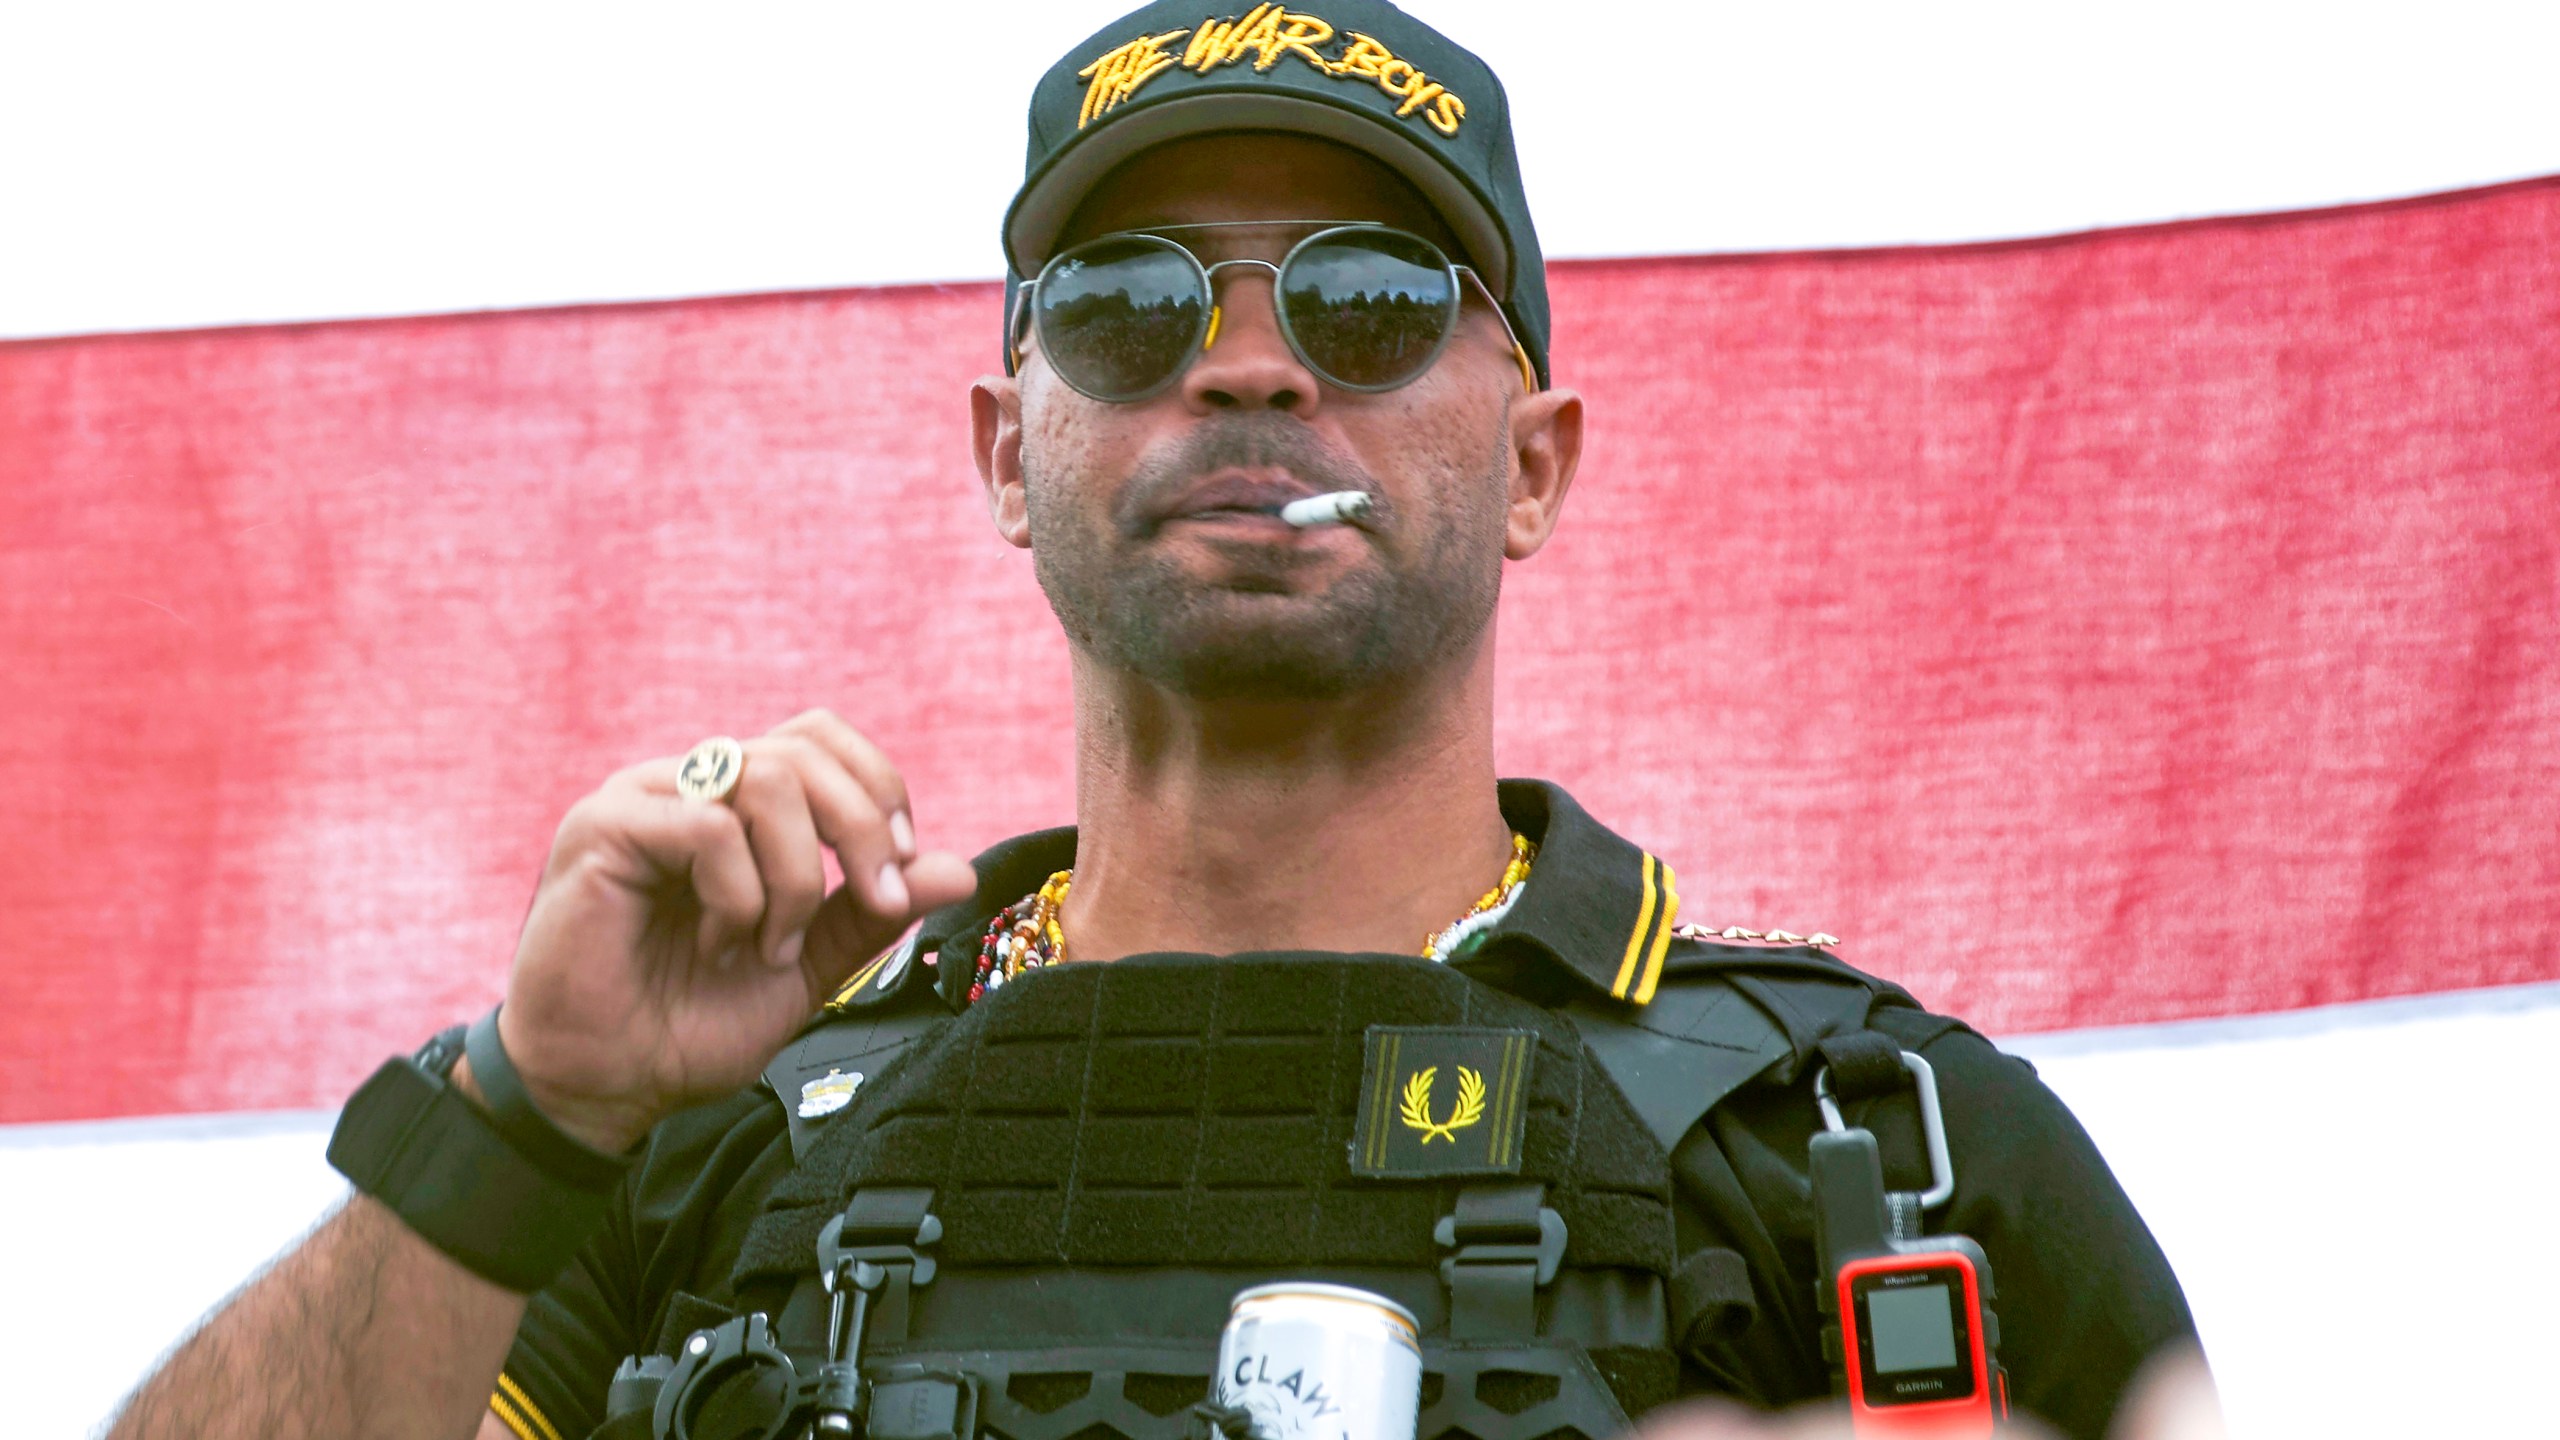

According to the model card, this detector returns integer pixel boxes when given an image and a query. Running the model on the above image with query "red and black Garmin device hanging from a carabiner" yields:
[1812,1053,2010,1440]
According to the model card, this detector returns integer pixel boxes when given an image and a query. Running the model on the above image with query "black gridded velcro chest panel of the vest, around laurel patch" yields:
[735,953,1674,1286]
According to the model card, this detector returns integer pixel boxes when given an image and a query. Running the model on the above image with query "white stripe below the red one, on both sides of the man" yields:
[0,984,2560,1440]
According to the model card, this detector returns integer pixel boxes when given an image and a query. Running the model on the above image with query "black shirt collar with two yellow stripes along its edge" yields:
[916,779,1679,1010]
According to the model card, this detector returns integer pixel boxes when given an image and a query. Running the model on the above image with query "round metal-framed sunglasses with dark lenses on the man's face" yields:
[1014,220,1539,402]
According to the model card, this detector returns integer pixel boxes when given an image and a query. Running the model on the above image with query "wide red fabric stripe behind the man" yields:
[0,182,2560,1120]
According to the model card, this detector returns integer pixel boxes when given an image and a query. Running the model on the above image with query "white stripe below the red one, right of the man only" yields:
[1996,984,2560,1440]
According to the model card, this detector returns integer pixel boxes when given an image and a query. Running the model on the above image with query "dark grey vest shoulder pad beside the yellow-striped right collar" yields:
[1564,938,1912,1153]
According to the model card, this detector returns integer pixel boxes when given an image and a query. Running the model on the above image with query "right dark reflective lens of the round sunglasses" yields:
[1280,231,1457,389]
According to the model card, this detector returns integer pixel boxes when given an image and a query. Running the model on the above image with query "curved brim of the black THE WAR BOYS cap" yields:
[1004,92,1510,295]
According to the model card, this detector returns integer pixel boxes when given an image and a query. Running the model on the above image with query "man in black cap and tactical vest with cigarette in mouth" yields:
[94,0,2191,1440]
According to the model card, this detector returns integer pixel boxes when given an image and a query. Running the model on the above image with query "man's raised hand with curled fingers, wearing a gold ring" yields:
[499,710,975,1150]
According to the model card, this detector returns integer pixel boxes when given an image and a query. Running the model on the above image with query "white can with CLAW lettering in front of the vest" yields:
[1216,1281,1423,1440]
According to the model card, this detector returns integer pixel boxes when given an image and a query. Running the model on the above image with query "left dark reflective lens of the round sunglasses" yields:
[1037,238,1208,400]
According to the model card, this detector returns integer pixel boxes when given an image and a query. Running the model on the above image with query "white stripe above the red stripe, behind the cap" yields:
[0,0,2560,336]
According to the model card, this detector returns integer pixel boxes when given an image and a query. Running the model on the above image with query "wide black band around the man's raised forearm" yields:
[328,1027,627,1294]
